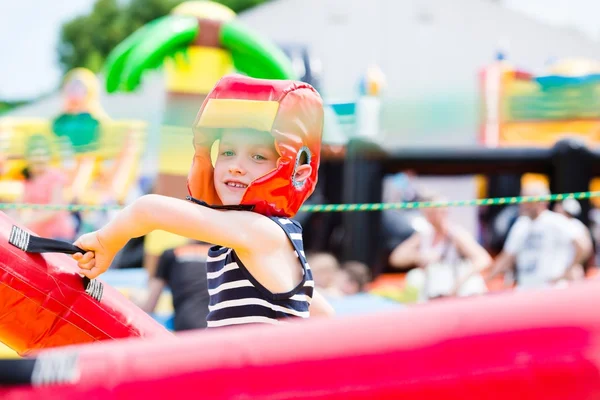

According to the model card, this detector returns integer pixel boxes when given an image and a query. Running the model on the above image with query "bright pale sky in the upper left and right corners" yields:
[0,0,600,100]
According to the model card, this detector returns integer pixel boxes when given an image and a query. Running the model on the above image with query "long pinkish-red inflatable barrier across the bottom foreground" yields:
[0,282,600,400]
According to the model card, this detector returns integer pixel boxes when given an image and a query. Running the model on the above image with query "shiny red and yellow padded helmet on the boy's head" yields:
[188,75,324,217]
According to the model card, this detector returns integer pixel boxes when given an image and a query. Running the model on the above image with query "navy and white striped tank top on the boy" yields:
[206,217,314,328]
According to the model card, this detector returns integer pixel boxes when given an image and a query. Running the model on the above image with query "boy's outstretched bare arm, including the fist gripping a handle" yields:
[73,194,285,279]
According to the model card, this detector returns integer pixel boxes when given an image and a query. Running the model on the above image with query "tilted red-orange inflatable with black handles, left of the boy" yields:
[0,212,173,355]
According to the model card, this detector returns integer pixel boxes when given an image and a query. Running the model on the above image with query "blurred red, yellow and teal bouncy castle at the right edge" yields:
[479,54,600,206]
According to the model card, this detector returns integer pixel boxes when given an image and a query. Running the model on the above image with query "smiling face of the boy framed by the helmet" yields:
[214,129,279,205]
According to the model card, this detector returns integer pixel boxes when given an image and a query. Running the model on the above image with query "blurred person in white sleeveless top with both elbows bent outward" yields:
[389,194,492,301]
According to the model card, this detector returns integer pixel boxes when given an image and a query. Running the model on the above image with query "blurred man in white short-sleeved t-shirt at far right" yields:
[487,183,584,289]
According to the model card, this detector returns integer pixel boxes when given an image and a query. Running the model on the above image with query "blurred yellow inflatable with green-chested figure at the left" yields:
[0,68,146,204]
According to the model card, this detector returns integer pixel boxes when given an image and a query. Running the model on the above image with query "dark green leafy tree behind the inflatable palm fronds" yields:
[58,0,268,73]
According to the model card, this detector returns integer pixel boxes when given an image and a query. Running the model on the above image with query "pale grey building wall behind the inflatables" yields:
[240,0,600,145]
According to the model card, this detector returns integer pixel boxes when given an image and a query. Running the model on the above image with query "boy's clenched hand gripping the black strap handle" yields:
[73,231,117,279]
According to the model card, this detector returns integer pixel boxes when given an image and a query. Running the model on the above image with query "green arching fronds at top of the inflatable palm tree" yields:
[106,1,296,93]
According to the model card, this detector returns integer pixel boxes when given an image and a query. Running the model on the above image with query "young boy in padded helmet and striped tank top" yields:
[73,75,333,328]
